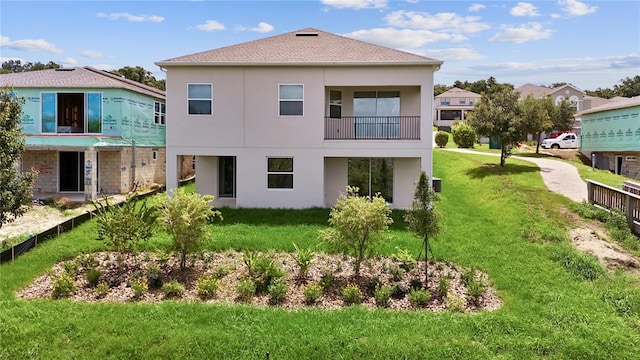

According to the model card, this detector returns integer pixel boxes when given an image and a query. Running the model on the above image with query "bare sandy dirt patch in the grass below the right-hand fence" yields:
[569,227,640,270]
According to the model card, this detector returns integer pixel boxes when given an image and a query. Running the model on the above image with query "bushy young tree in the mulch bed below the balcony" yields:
[319,186,393,278]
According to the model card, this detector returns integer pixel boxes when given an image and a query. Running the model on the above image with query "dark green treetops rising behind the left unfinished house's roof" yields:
[0,60,166,90]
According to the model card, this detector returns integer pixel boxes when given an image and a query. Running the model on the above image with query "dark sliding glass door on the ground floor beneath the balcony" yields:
[347,158,393,203]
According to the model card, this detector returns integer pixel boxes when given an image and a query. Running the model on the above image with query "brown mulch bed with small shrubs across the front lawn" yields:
[17,251,502,312]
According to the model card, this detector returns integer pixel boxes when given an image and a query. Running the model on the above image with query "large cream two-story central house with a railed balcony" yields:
[156,28,442,208]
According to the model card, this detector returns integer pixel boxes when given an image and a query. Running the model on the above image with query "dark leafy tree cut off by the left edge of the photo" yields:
[0,87,37,227]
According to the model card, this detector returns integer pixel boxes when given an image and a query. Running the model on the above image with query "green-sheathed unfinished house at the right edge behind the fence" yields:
[580,96,640,180]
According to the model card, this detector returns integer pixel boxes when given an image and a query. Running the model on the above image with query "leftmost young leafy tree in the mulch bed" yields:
[93,197,156,270]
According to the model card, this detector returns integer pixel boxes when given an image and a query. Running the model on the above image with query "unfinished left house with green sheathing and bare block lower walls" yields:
[0,67,185,199]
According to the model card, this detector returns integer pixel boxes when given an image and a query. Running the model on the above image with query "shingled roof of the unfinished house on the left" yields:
[0,66,165,98]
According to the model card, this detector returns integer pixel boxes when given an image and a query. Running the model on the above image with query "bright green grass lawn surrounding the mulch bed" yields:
[0,151,640,359]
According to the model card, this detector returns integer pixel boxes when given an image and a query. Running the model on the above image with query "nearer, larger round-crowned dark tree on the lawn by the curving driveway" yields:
[467,84,528,166]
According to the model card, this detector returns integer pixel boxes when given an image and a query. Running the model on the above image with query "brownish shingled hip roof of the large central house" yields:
[156,28,442,67]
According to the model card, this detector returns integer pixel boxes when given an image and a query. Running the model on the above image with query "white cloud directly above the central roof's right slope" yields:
[343,28,466,49]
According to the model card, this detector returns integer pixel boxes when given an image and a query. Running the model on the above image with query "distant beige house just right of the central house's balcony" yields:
[434,87,481,128]
